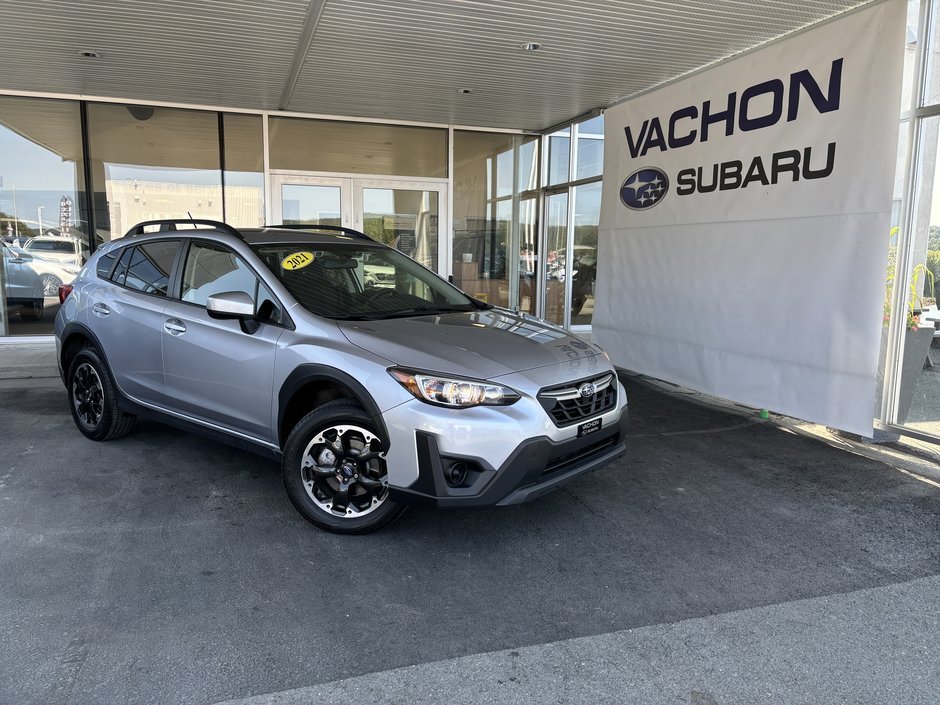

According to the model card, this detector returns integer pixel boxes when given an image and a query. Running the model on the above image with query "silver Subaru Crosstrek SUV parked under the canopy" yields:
[55,220,627,533]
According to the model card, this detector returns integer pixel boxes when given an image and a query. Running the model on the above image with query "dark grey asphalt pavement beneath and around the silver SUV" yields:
[0,368,940,705]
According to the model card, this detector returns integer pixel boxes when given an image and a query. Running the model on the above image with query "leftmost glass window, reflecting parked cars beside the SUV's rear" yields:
[0,96,89,335]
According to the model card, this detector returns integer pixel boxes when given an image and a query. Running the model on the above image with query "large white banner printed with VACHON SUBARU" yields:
[593,0,906,436]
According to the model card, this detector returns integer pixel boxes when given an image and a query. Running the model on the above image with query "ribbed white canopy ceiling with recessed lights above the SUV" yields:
[0,0,866,130]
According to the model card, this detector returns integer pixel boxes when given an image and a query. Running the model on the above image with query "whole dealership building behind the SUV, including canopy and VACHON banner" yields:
[0,0,940,442]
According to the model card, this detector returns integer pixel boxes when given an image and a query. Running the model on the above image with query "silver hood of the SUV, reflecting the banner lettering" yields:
[338,309,603,379]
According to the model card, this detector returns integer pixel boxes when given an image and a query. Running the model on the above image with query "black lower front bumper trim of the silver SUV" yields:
[389,408,627,507]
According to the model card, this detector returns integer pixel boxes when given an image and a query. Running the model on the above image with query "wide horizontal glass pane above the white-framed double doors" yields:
[268,118,447,178]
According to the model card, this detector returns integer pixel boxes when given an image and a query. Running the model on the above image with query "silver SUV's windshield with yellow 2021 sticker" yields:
[253,243,480,320]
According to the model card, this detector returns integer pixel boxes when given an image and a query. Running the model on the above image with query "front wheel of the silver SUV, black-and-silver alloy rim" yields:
[281,399,404,534]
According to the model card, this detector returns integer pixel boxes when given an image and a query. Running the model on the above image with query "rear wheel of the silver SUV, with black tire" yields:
[66,348,136,441]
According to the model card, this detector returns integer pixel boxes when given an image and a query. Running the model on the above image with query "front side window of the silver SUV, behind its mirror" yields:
[181,242,281,323]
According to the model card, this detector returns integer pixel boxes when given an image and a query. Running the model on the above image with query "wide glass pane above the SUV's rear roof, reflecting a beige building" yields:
[88,103,222,239]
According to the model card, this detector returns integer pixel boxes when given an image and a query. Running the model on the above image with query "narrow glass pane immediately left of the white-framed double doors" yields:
[222,114,264,228]
